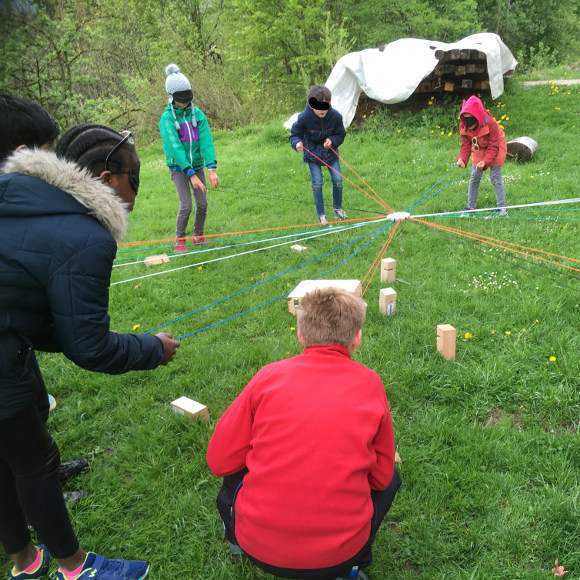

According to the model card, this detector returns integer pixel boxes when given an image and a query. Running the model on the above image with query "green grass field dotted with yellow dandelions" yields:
[0,82,580,580]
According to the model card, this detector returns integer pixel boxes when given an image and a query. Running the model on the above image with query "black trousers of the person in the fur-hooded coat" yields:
[0,361,79,558]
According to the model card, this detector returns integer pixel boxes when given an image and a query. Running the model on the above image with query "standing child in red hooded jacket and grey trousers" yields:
[457,96,507,217]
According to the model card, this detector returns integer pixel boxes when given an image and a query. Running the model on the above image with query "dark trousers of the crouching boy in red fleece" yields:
[217,469,401,580]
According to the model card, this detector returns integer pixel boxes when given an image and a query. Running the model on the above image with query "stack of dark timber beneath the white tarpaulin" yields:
[415,48,489,93]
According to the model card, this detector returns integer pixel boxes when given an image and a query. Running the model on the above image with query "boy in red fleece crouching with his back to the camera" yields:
[207,287,401,580]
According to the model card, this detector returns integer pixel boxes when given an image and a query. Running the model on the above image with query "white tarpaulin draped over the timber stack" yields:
[284,33,518,129]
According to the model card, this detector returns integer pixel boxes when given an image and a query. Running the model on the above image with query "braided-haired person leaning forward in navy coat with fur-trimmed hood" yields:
[0,111,179,580]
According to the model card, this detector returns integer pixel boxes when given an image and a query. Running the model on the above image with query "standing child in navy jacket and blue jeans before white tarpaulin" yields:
[290,85,347,225]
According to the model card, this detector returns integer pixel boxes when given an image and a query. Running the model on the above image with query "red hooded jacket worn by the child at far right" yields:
[457,95,507,170]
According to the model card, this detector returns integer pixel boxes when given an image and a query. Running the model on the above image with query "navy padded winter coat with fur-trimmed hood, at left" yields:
[0,150,163,419]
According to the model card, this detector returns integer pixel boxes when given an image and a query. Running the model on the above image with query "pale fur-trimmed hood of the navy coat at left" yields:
[0,149,128,240]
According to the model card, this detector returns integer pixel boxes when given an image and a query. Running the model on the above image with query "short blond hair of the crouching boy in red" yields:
[297,286,367,348]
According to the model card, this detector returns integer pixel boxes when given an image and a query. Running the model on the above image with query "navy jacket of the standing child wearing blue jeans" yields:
[290,103,346,165]
